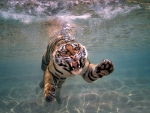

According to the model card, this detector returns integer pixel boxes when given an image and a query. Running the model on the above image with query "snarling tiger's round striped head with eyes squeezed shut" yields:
[53,42,87,75]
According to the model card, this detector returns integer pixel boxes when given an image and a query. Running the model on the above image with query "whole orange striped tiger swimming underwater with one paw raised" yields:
[40,18,114,103]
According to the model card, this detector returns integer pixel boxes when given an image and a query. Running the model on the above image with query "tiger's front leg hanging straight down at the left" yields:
[44,70,56,102]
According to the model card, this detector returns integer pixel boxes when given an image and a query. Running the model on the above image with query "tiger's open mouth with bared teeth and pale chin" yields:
[70,60,82,75]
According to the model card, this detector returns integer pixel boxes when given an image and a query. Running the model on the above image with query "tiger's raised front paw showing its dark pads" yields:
[95,59,114,78]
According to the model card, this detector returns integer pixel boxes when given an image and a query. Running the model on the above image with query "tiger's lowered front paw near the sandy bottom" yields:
[44,83,56,102]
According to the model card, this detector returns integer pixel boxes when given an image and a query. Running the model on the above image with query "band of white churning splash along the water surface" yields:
[0,0,140,24]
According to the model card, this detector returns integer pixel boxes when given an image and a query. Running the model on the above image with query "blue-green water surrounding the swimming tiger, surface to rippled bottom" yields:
[0,0,150,113]
